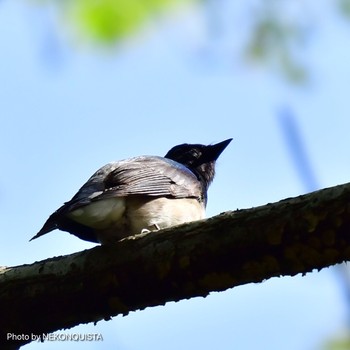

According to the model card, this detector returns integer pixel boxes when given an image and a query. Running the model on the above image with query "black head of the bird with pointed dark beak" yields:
[165,139,232,188]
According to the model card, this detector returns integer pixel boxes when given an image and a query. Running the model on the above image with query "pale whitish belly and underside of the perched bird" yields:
[69,196,205,243]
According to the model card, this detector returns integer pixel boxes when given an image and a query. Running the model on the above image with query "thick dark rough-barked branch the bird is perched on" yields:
[0,183,350,349]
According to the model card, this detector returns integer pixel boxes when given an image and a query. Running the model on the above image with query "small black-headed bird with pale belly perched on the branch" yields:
[30,139,232,244]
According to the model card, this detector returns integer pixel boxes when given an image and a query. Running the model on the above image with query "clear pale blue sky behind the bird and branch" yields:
[0,1,350,350]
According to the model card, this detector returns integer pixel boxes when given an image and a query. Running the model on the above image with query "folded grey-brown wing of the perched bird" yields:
[65,156,202,211]
